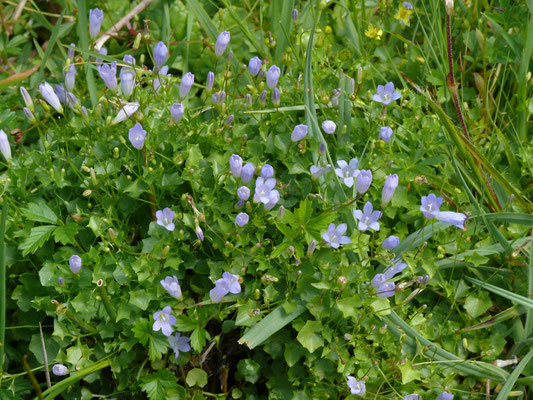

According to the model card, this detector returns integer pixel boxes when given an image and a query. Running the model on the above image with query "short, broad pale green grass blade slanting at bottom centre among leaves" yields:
[239,303,307,349]
